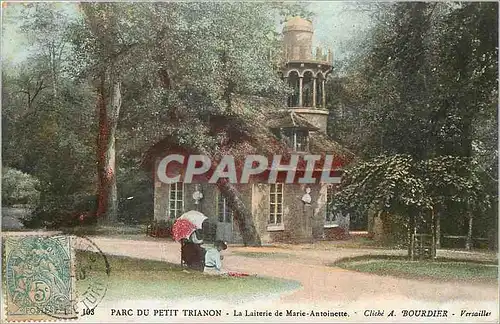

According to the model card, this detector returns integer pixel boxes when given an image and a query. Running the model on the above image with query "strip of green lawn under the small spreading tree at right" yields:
[332,256,498,283]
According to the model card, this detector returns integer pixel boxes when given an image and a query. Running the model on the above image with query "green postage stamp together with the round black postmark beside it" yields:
[4,235,111,322]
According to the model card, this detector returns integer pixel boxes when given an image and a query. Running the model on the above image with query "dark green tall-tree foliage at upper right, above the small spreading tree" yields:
[328,3,498,162]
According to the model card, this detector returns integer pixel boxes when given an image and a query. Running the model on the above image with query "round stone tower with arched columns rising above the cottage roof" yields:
[282,17,333,133]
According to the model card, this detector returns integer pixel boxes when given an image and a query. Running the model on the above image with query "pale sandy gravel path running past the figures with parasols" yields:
[86,237,498,303]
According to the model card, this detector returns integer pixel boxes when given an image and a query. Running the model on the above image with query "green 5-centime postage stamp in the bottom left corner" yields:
[4,235,76,321]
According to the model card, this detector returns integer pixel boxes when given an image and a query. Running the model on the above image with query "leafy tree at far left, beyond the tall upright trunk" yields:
[2,4,95,226]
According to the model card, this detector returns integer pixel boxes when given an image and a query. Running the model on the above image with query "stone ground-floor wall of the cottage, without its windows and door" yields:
[154,163,346,244]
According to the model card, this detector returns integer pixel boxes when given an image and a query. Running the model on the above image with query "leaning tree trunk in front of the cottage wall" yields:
[217,179,262,246]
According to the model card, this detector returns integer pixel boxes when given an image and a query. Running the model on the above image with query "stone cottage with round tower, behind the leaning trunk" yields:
[143,17,354,243]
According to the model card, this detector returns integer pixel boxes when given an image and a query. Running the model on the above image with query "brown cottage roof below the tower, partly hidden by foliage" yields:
[142,97,354,175]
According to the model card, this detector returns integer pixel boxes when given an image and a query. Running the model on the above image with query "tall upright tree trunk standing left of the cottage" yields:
[97,74,121,223]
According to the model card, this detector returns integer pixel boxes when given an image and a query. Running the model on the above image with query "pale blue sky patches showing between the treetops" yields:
[2,1,376,69]
